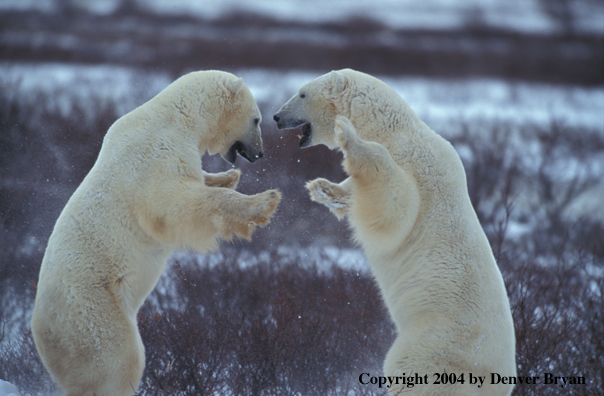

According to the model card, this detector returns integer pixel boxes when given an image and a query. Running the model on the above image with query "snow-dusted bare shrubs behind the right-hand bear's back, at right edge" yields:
[453,122,604,395]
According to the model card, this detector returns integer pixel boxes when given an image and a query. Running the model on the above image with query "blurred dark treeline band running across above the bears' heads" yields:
[0,8,604,85]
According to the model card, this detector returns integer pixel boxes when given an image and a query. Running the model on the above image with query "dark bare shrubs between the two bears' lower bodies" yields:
[134,251,393,395]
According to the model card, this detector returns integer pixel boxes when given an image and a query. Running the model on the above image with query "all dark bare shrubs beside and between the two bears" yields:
[0,69,604,396]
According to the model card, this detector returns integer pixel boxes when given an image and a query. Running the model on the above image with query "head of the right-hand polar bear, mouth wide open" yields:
[273,71,349,148]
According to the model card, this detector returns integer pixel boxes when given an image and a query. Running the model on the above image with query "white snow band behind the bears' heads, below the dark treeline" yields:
[0,63,604,134]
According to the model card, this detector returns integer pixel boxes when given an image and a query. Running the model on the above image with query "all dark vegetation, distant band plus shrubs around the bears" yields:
[0,0,604,396]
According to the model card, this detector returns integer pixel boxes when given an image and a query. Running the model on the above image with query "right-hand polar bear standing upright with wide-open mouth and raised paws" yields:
[274,69,516,395]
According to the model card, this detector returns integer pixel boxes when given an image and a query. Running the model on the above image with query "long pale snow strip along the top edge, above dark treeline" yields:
[138,0,555,32]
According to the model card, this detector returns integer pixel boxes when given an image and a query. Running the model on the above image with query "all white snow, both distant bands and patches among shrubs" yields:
[0,0,604,396]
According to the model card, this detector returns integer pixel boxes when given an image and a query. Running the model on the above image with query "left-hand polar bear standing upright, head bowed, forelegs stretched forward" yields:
[31,71,281,396]
